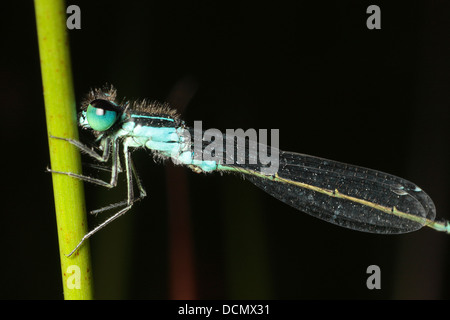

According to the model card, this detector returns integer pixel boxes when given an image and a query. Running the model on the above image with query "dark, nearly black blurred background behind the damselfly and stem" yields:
[0,0,450,299]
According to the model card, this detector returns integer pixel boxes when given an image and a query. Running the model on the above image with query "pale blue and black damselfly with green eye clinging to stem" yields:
[48,87,450,256]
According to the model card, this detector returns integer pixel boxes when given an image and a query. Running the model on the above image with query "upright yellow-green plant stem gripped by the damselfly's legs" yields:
[34,0,93,300]
